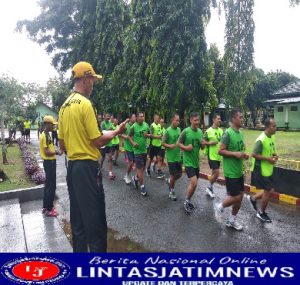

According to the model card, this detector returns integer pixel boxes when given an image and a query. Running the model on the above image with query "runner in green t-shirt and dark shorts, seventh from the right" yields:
[128,112,151,196]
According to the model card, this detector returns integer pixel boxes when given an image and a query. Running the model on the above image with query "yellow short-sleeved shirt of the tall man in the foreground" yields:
[58,92,102,161]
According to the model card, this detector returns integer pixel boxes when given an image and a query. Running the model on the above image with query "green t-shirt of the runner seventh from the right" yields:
[129,122,150,154]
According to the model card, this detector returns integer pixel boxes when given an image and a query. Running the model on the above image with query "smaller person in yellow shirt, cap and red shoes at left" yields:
[40,116,61,217]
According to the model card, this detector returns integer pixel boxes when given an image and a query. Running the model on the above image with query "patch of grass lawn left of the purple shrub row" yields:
[0,144,35,192]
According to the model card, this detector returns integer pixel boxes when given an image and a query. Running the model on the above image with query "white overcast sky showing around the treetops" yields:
[0,0,300,85]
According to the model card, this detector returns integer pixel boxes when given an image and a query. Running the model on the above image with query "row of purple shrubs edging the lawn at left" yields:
[18,139,45,184]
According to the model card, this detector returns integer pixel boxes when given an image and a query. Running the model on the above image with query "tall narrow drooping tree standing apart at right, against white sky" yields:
[224,0,254,108]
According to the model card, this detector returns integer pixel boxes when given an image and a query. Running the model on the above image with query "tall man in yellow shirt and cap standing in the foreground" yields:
[58,62,127,252]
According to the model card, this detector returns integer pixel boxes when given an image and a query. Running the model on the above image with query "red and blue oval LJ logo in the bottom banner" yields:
[1,258,70,285]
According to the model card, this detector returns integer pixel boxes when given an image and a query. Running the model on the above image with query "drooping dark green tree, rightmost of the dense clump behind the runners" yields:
[146,0,215,121]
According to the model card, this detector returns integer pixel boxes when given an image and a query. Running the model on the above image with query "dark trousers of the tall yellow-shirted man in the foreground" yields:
[67,160,107,252]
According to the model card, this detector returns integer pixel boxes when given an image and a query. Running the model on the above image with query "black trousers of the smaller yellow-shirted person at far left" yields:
[43,159,56,211]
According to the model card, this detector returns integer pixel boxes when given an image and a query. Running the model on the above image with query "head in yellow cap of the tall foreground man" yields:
[72,61,102,97]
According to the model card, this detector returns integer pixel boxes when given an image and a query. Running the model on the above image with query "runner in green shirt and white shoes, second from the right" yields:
[215,109,249,231]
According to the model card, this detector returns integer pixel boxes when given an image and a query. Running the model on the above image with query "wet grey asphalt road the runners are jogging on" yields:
[27,130,300,252]
